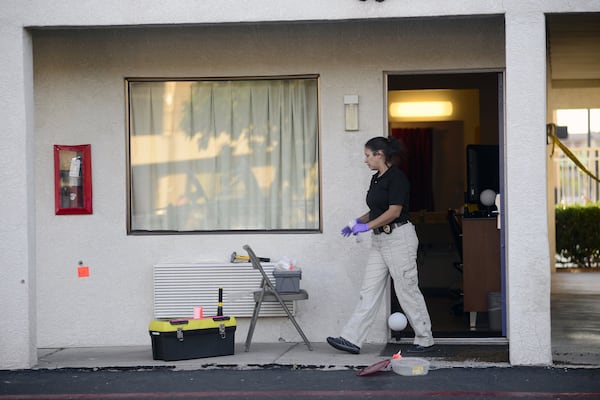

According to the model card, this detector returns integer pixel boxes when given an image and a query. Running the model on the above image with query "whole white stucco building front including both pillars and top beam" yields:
[0,0,600,368]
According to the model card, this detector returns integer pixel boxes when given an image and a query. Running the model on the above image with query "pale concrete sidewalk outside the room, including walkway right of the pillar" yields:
[34,282,600,370]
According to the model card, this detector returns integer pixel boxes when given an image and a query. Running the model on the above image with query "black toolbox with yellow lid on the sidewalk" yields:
[148,316,236,361]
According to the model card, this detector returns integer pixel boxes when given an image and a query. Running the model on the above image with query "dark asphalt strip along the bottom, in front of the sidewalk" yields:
[0,366,600,400]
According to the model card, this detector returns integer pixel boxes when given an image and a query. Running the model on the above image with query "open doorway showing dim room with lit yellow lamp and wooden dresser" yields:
[387,72,504,340]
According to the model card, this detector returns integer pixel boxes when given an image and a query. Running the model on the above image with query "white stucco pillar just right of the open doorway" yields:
[505,14,552,364]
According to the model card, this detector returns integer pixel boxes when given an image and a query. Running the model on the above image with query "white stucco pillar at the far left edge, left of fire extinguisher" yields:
[0,18,37,367]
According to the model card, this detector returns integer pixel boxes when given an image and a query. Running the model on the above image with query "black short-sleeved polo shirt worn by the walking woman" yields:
[367,165,410,222]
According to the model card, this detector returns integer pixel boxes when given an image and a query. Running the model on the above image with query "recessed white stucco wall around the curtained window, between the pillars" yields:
[33,17,504,347]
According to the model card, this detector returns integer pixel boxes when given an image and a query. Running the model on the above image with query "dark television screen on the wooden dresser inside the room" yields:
[466,144,500,203]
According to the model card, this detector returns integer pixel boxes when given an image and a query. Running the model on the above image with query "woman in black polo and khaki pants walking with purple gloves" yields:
[327,137,434,354]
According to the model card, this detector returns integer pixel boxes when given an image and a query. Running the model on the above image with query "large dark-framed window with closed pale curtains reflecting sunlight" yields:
[127,76,320,233]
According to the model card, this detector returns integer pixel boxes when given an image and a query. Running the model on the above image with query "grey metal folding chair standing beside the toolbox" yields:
[244,245,312,351]
